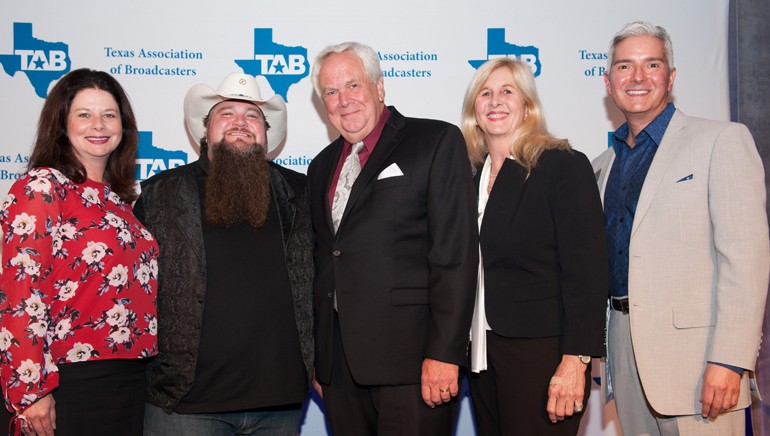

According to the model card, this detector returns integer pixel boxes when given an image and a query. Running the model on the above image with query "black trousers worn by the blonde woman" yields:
[468,331,591,436]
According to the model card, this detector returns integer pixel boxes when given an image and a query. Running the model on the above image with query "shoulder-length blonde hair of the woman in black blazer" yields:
[460,58,571,173]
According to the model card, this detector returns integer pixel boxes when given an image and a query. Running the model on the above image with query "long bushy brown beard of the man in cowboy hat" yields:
[205,141,270,229]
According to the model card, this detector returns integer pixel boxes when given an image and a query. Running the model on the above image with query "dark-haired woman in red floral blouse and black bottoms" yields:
[0,69,158,436]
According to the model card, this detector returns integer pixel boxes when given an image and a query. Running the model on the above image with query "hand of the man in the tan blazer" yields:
[700,363,741,421]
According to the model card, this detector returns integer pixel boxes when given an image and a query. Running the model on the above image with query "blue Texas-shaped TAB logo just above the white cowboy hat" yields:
[235,28,310,102]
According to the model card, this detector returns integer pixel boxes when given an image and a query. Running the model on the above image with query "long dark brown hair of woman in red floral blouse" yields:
[28,68,139,203]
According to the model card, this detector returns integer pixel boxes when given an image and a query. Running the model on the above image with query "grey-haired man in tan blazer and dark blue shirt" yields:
[593,22,770,435]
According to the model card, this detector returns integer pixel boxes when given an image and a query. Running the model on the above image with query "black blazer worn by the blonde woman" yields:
[476,150,608,356]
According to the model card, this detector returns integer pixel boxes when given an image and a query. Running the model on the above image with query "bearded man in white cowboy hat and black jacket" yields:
[134,73,313,436]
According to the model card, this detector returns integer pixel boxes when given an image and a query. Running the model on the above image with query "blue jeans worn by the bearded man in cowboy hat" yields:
[144,403,302,436]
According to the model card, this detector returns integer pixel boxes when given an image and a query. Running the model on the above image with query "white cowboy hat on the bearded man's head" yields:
[184,73,286,153]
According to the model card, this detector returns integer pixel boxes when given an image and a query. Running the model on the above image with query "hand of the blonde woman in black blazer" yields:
[546,354,588,422]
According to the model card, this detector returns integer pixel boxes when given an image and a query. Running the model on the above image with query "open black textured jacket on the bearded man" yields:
[134,154,314,412]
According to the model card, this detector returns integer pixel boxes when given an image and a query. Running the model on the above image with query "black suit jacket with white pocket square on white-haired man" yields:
[308,107,478,385]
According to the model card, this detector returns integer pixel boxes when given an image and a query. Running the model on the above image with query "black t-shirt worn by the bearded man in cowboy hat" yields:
[175,189,308,413]
